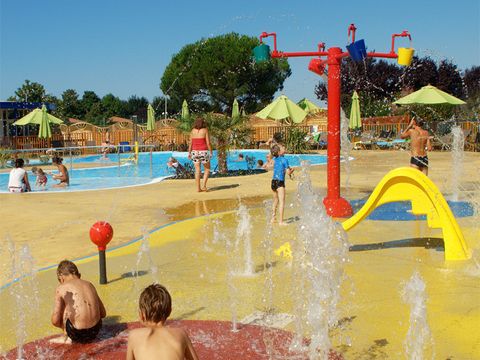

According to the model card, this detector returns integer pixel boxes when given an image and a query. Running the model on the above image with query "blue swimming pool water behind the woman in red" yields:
[0,150,327,193]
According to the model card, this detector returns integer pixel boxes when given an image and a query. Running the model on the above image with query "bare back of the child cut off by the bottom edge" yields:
[128,326,196,360]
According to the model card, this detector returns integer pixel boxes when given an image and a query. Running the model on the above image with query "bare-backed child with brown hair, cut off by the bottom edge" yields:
[127,284,198,360]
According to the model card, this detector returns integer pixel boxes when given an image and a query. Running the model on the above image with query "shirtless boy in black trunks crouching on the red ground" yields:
[52,260,106,343]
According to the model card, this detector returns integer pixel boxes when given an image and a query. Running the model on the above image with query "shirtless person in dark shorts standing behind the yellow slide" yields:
[400,118,432,175]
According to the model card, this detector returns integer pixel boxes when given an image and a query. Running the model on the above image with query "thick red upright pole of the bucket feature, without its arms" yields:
[323,47,353,217]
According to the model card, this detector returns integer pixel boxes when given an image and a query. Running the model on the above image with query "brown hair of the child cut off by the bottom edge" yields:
[138,284,172,323]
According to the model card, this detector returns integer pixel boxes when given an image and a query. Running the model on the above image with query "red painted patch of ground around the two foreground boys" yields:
[6,320,342,360]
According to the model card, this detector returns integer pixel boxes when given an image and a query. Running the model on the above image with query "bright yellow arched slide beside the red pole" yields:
[342,167,471,260]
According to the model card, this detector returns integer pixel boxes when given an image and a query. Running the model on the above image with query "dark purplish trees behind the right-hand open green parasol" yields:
[315,56,474,117]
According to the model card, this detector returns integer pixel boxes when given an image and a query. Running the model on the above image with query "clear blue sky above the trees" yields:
[0,0,480,105]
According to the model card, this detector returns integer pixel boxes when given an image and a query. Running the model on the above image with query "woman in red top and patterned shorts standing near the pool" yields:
[188,117,212,192]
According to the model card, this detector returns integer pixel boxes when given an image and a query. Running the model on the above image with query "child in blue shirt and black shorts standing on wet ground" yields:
[270,145,293,226]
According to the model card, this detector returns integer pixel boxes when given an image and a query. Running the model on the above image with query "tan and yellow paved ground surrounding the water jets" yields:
[0,151,480,359]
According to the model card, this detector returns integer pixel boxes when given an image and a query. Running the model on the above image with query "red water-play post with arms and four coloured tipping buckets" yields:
[253,24,413,217]
